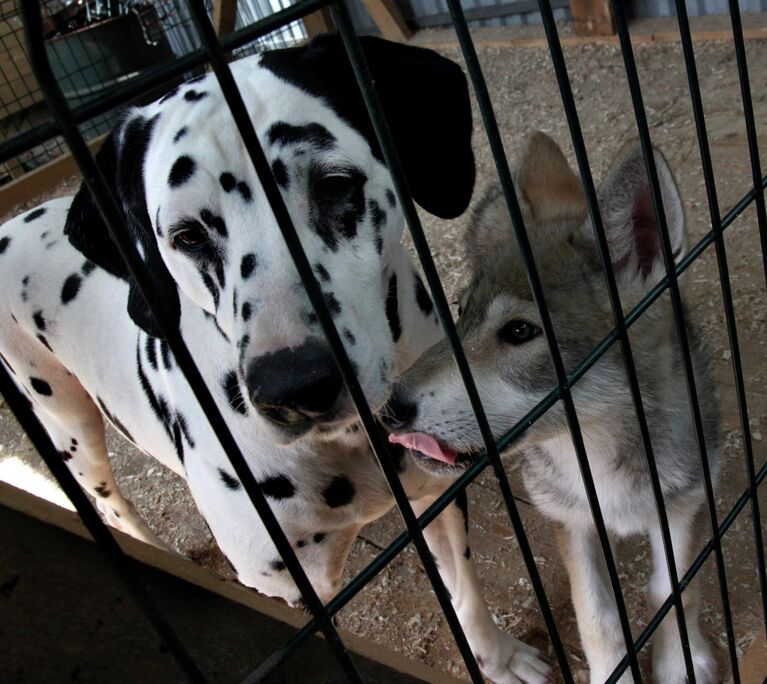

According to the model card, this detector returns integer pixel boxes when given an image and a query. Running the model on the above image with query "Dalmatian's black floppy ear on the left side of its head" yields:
[65,114,180,337]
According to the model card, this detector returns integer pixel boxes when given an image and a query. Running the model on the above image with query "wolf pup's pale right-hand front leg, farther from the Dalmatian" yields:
[649,505,716,684]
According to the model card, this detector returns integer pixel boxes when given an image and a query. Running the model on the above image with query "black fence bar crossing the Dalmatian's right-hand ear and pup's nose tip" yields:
[333,0,572,681]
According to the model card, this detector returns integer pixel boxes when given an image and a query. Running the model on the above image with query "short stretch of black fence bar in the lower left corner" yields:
[0,363,208,684]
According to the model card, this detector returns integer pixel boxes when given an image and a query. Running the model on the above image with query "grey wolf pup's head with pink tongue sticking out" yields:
[385,133,684,476]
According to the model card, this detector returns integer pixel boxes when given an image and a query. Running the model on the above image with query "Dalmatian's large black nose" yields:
[246,340,343,425]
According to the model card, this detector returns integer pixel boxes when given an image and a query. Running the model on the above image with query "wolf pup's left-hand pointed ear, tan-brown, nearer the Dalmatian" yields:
[517,131,587,222]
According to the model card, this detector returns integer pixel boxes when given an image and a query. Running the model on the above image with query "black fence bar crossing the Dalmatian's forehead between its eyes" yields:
[184,0,482,682]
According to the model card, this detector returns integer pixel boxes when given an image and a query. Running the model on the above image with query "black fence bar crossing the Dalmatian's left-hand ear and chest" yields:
[22,2,362,682]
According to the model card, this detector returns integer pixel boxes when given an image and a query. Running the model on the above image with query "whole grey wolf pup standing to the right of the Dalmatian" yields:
[395,133,718,684]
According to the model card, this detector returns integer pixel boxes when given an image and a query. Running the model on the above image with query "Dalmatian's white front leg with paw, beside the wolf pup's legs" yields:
[412,493,551,684]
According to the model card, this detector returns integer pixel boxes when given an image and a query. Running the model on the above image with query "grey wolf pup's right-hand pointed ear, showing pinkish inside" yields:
[584,142,685,282]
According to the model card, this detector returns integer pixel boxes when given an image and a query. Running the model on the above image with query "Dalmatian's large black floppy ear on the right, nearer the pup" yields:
[261,36,475,218]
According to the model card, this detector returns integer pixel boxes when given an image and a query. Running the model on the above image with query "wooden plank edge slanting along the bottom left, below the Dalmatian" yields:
[0,481,462,684]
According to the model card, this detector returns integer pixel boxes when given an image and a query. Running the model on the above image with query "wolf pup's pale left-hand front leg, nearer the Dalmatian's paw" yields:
[560,525,632,684]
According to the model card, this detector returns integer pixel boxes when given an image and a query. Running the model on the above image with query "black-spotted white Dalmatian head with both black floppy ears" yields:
[67,37,474,441]
